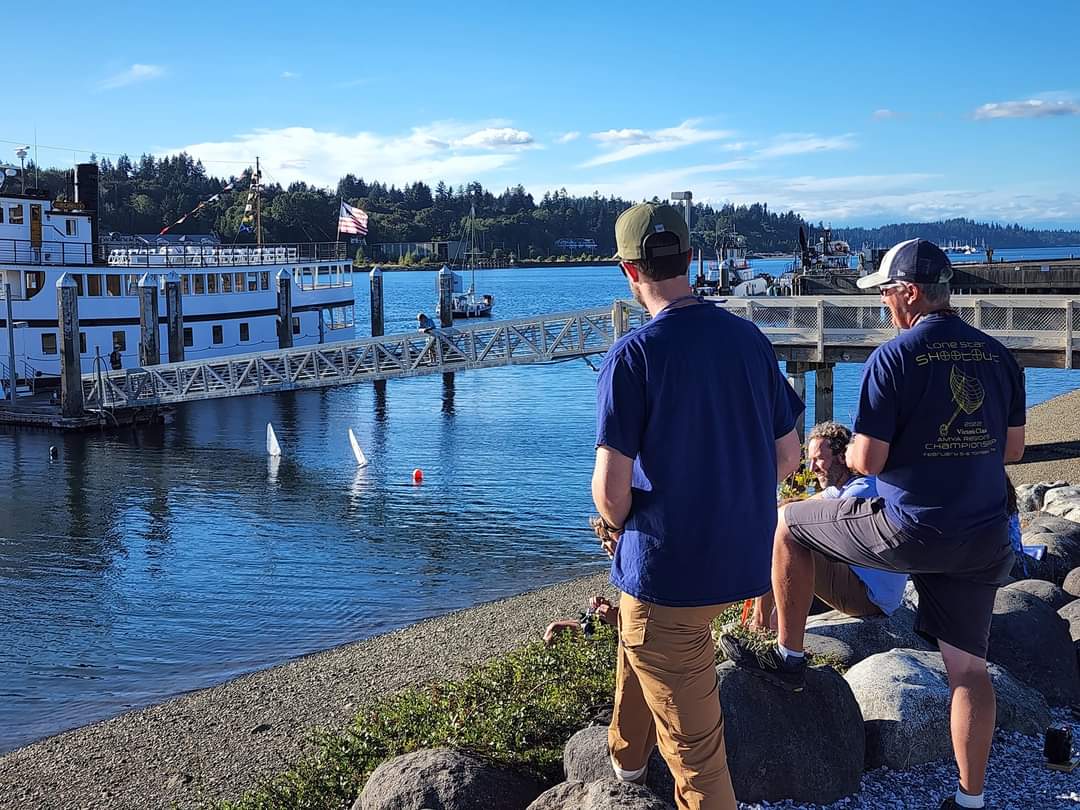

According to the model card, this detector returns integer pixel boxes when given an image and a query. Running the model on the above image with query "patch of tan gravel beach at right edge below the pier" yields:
[1009,391,1080,486]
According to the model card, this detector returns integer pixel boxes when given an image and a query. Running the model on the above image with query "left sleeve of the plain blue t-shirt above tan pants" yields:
[596,349,645,458]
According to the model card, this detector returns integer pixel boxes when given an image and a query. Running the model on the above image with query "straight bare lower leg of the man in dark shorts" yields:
[937,642,997,795]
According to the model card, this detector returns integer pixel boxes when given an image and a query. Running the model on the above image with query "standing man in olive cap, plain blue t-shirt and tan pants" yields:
[593,204,802,810]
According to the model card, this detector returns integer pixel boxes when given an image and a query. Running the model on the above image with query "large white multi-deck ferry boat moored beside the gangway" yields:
[0,164,355,381]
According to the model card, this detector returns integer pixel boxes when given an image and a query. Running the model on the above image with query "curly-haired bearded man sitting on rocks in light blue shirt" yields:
[751,422,907,630]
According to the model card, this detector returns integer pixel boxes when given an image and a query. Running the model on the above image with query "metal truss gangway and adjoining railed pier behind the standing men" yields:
[82,295,1080,408]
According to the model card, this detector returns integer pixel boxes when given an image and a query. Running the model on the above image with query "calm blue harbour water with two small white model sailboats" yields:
[0,252,1080,751]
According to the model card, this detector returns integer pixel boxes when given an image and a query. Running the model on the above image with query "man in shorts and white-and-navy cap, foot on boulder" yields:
[723,239,1025,808]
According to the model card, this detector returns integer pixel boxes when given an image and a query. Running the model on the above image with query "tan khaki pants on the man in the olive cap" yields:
[608,594,735,810]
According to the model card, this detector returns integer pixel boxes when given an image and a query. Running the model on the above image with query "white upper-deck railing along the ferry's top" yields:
[99,242,346,268]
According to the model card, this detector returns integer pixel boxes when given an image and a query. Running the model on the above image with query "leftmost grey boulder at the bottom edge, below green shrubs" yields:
[353,748,543,810]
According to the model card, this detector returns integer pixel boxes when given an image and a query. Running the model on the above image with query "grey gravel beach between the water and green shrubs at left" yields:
[0,572,613,810]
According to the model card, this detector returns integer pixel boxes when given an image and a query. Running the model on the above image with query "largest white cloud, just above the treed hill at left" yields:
[164,121,532,187]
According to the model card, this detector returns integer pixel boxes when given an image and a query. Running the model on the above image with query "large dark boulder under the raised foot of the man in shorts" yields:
[716,662,864,805]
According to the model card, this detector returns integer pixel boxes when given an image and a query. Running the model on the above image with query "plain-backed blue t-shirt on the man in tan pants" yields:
[596,305,802,607]
